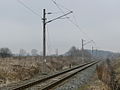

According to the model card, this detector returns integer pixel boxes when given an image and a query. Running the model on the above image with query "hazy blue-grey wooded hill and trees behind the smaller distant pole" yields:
[64,46,120,59]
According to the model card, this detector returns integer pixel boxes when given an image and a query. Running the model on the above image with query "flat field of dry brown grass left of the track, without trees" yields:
[0,57,82,86]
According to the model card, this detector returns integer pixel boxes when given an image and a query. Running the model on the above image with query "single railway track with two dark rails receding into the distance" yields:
[0,61,99,90]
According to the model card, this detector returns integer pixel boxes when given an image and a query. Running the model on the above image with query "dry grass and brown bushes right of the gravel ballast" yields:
[79,59,120,90]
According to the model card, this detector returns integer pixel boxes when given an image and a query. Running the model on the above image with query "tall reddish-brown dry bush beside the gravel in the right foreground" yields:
[97,59,119,90]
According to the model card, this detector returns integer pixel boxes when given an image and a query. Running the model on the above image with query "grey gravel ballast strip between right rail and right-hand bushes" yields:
[55,65,96,90]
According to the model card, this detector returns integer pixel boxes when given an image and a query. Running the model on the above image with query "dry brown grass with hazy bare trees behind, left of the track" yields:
[0,47,90,86]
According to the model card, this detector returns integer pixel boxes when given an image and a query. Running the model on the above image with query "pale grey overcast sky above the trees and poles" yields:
[0,0,120,54]
